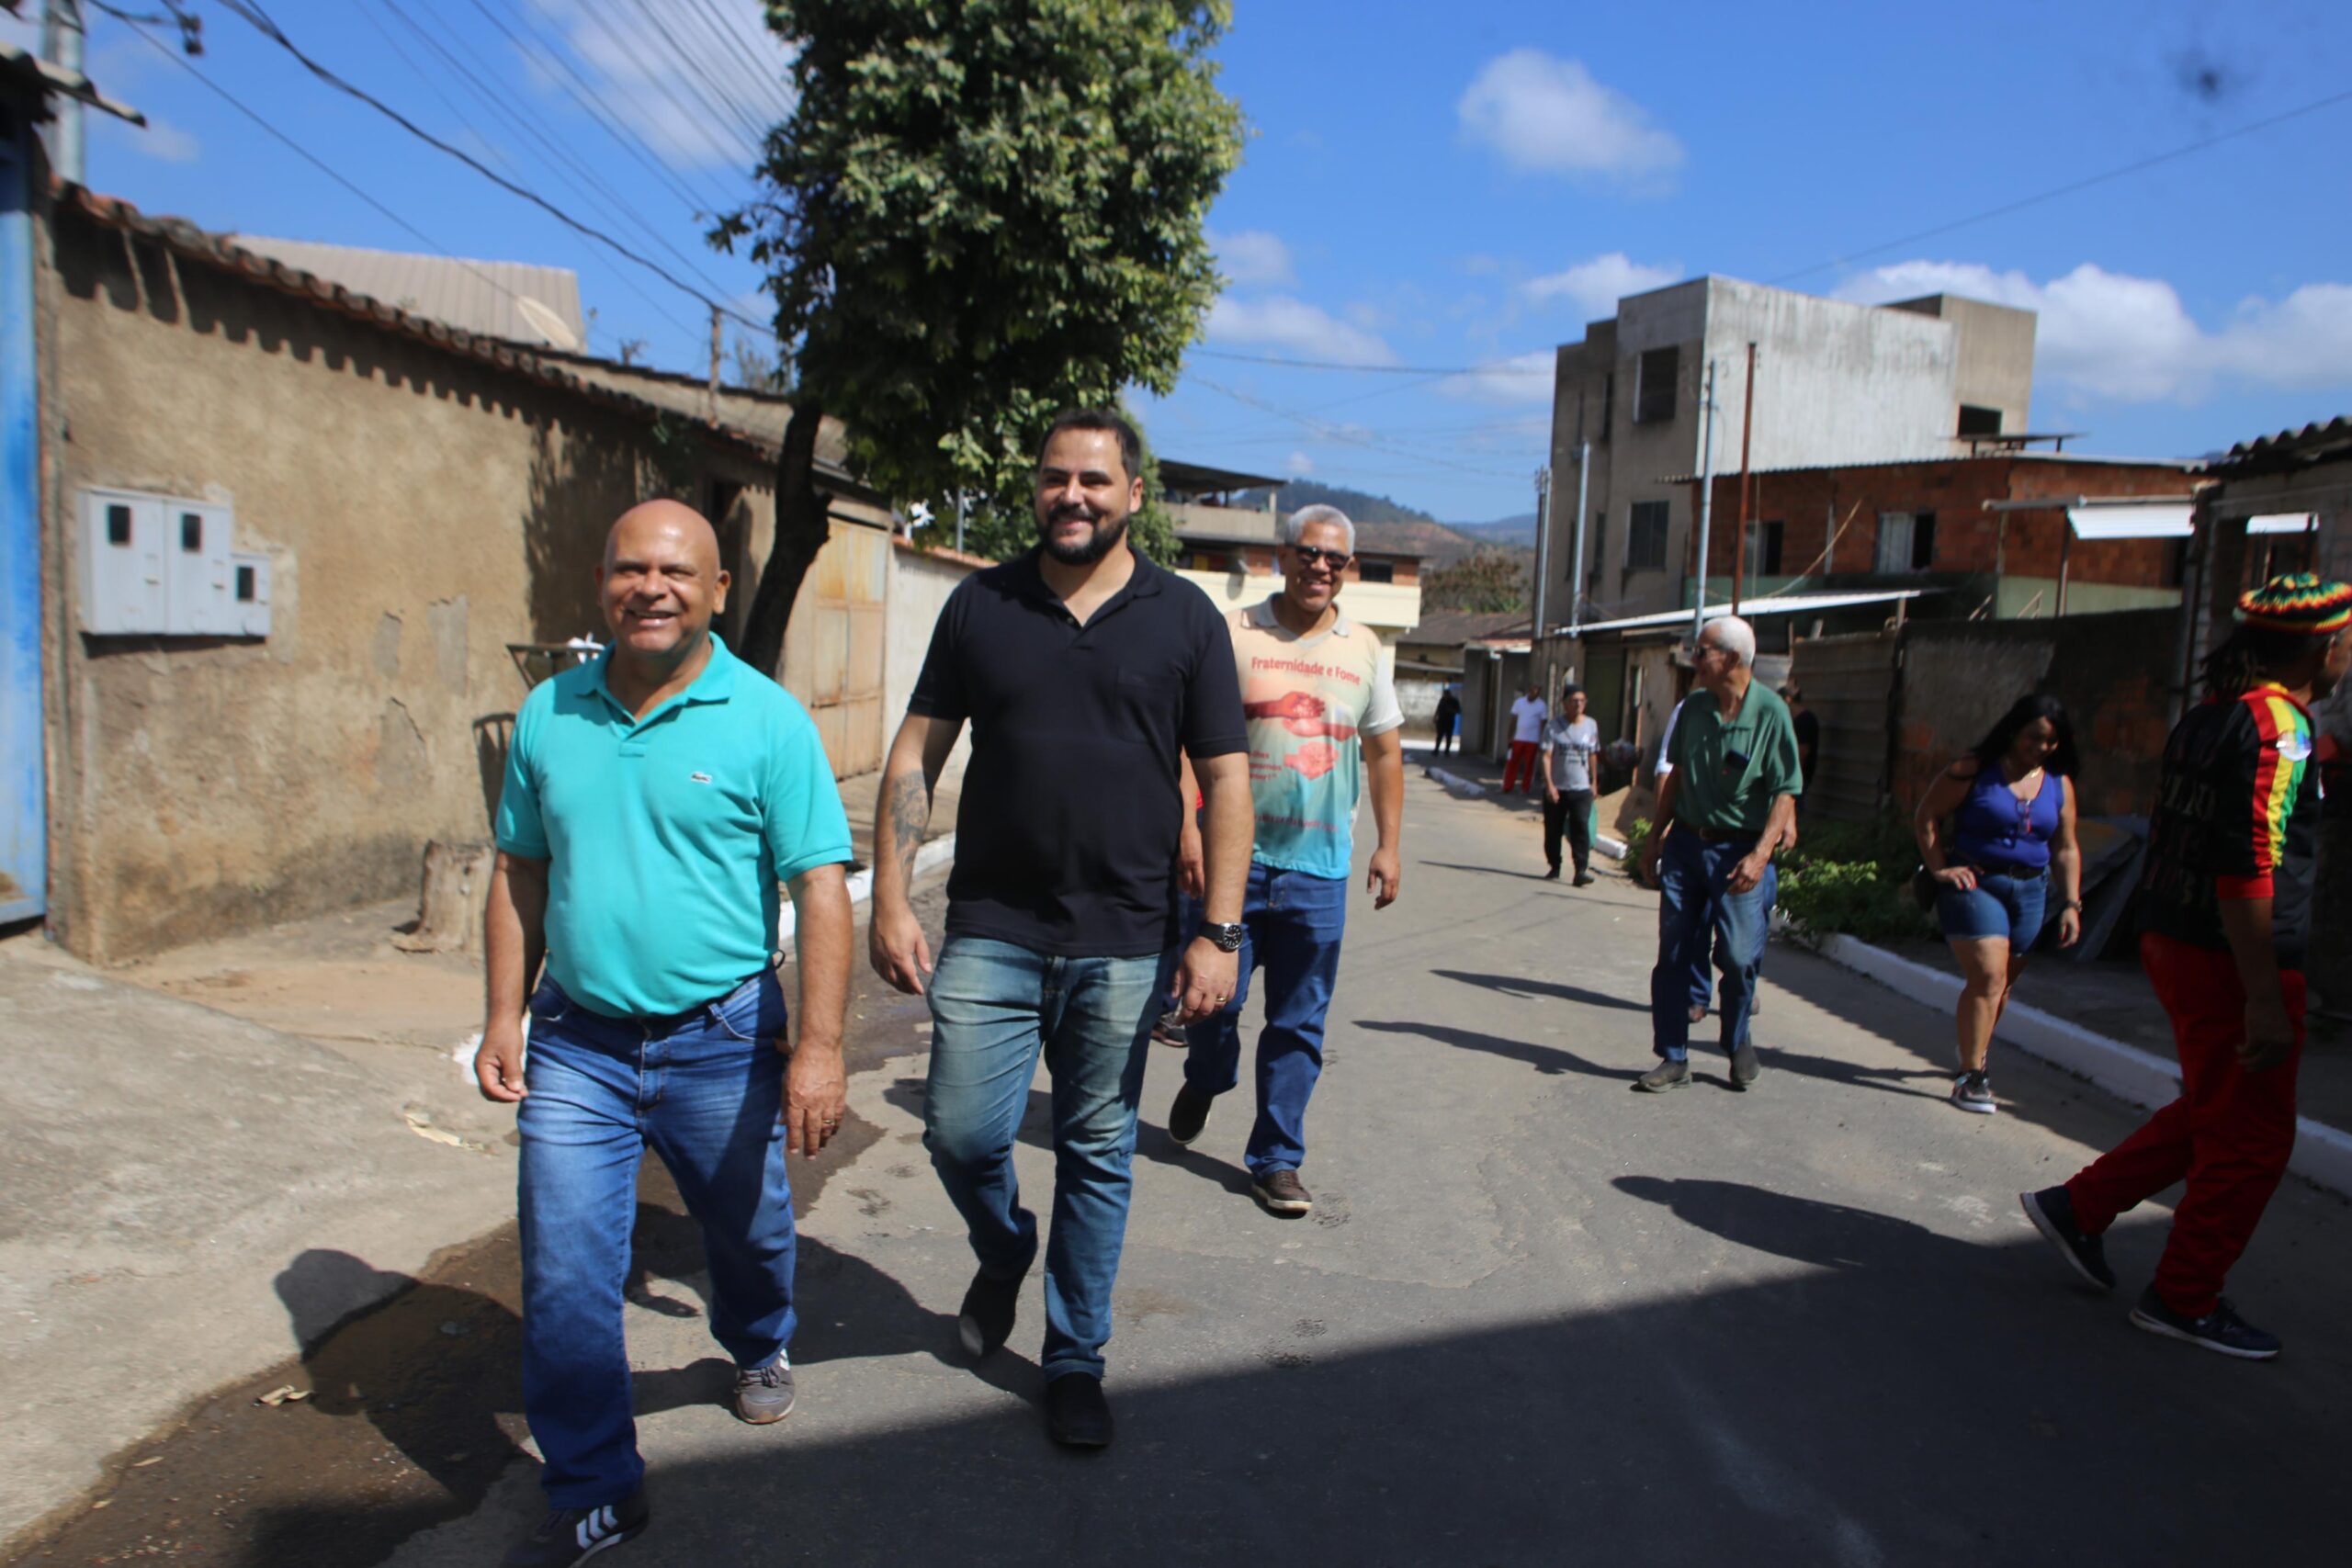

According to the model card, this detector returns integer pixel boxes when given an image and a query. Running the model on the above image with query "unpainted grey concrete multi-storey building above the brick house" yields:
[1545,277,2034,623]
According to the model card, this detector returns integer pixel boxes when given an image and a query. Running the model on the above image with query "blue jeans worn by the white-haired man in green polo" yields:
[1649,828,1781,1063]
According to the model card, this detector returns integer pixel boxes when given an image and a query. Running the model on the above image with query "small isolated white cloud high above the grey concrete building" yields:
[1456,50,1684,181]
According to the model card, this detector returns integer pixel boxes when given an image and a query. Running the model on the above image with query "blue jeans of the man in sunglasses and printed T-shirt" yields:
[1183,863,1348,1176]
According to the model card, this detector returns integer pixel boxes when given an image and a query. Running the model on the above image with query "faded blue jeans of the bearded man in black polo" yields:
[922,936,1171,1380]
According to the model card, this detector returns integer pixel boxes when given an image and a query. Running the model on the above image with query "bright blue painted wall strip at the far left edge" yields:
[0,98,50,921]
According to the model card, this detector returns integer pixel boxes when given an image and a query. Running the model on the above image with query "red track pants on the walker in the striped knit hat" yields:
[2065,936,2302,1316]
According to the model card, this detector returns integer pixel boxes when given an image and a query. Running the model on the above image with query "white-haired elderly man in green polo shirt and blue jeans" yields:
[1637,616,1804,1093]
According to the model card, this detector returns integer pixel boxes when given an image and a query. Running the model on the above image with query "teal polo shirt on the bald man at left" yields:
[499,637,849,1018]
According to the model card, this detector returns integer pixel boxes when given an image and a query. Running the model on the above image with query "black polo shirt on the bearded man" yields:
[908,550,1249,957]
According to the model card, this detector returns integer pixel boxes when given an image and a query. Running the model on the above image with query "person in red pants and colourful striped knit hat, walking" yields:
[2018,573,2352,1361]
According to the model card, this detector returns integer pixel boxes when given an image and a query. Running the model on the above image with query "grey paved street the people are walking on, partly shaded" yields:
[336,776,2352,1568]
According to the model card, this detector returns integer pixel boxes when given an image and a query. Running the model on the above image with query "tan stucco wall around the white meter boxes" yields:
[47,214,769,959]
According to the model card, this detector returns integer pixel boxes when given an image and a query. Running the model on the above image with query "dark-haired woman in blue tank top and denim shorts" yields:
[1912,696,2082,1117]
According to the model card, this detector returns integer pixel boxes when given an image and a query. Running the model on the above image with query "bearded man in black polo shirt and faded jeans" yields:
[868,412,1251,1448]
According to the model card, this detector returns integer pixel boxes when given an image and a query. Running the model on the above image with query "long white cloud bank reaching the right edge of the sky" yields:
[1839,261,2352,402]
